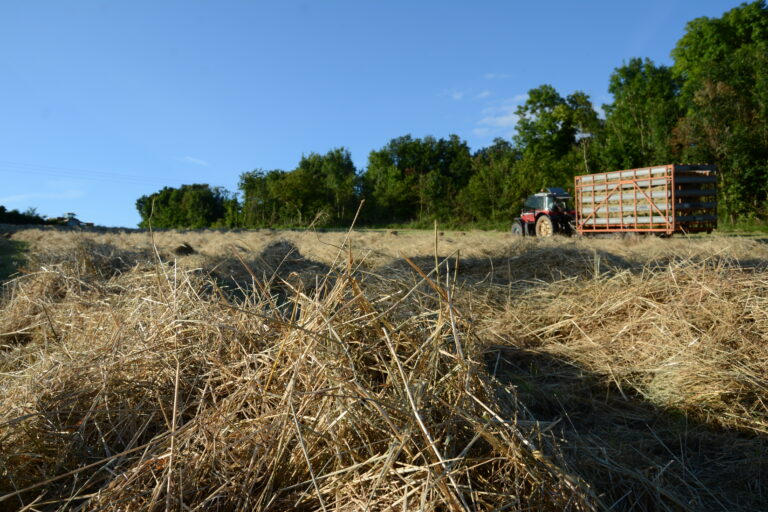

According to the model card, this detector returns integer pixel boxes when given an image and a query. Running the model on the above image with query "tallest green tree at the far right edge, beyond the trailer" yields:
[672,0,768,221]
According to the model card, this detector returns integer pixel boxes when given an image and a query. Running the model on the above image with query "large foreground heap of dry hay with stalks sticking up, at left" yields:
[0,242,600,510]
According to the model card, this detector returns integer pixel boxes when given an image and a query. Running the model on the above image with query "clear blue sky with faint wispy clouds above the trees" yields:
[0,0,740,227]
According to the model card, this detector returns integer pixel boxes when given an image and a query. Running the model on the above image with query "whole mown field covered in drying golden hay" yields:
[0,229,768,511]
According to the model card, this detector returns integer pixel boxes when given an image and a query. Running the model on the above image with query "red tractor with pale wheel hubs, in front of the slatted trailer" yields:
[512,187,576,236]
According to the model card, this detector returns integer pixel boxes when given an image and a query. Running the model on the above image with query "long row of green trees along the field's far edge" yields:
[136,0,768,228]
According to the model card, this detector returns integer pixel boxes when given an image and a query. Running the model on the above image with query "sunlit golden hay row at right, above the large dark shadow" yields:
[488,254,768,434]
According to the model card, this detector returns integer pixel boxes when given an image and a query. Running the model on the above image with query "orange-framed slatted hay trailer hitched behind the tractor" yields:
[574,164,717,235]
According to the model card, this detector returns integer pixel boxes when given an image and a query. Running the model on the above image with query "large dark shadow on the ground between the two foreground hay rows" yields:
[485,346,768,511]
